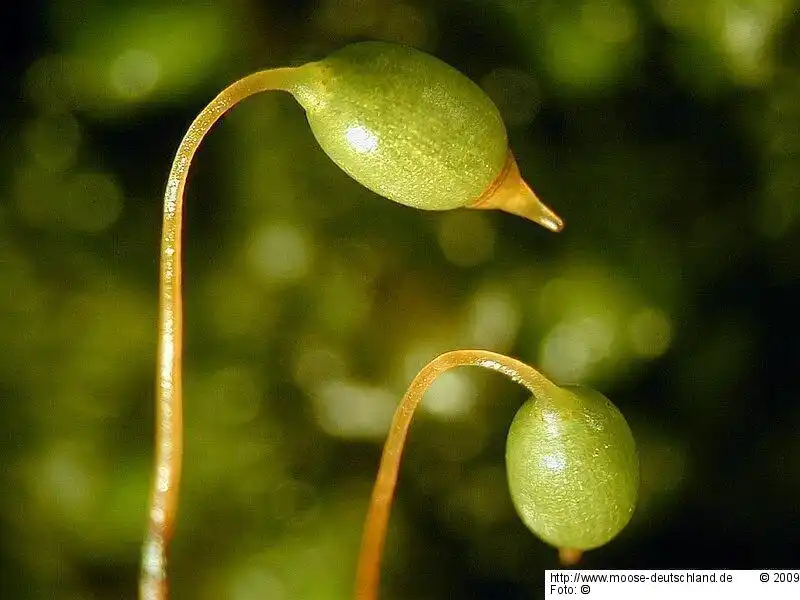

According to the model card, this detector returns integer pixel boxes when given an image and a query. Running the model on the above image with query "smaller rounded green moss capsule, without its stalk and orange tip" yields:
[506,386,639,550]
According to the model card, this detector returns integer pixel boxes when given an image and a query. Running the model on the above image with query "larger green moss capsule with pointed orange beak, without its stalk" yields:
[289,42,563,231]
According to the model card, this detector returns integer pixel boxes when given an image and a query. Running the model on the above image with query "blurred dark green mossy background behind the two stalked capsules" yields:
[0,0,800,600]
